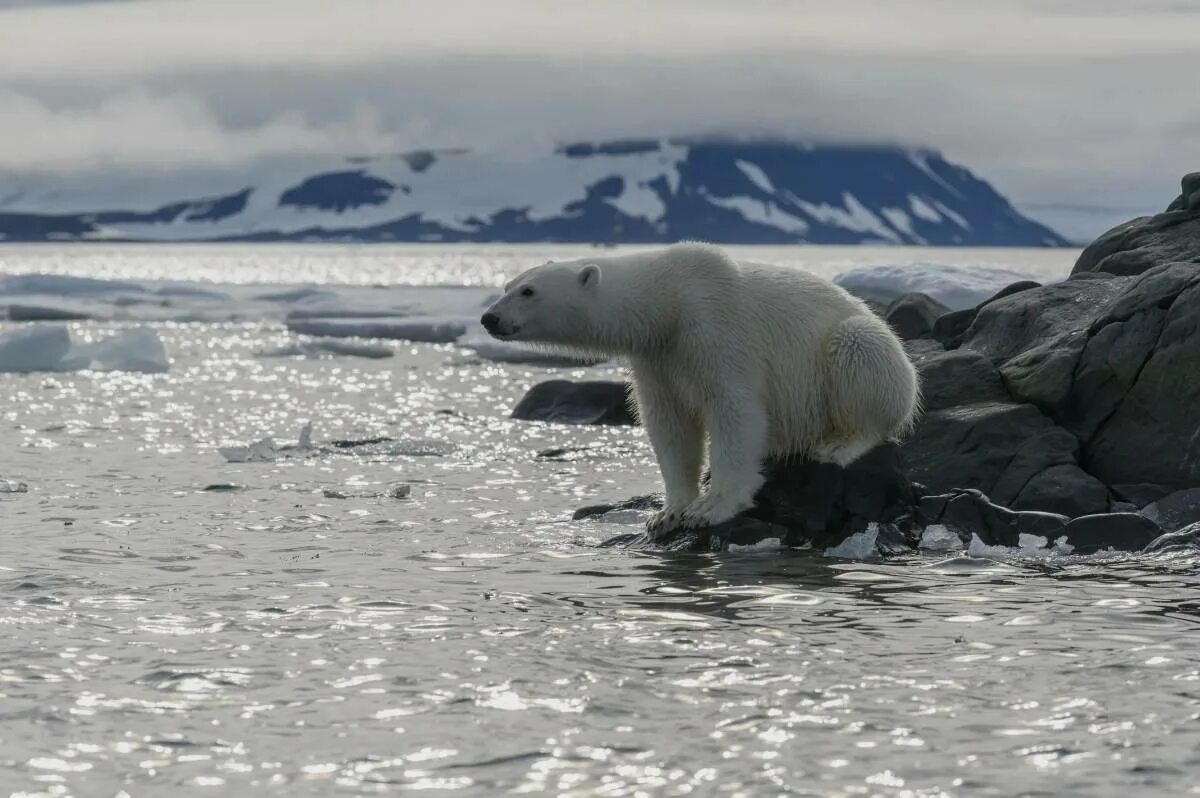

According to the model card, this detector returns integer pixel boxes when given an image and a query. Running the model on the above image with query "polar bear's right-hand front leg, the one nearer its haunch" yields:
[683,389,768,527]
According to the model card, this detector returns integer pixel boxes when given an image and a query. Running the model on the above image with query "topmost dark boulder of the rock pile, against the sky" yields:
[1072,172,1200,275]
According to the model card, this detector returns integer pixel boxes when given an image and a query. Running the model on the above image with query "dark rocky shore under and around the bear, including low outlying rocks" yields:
[520,173,1200,553]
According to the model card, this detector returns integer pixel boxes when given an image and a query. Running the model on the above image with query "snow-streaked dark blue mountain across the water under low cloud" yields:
[0,139,1067,246]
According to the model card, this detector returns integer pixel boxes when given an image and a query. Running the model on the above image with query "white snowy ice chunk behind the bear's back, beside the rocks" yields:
[834,263,1045,311]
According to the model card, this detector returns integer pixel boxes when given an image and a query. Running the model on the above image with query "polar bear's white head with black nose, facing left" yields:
[480,260,600,338]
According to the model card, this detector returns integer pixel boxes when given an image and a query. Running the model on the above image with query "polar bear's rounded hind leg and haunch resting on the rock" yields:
[816,316,920,466]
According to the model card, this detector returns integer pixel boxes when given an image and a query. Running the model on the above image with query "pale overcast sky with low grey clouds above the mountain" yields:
[0,0,1200,220]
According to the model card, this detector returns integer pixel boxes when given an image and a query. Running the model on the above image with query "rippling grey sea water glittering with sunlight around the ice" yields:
[0,245,1200,798]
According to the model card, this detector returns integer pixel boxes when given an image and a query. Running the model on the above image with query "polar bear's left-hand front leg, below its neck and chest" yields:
[637,378,704,540]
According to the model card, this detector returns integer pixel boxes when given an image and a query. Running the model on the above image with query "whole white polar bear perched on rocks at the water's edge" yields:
[480,244,919,538]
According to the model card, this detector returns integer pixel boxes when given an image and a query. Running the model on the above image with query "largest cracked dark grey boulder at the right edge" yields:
[955,263,1200,492]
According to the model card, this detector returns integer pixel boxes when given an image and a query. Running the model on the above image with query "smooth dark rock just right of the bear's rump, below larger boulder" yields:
[904,402,1079,504]
